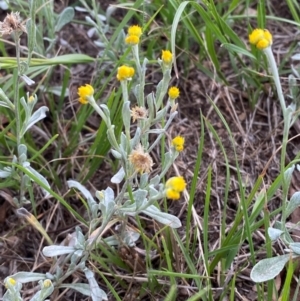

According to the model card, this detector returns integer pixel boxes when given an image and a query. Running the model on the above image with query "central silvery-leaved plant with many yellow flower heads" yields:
[4,25,186,301]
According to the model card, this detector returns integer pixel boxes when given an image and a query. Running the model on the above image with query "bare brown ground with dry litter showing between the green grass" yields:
[0,1,300,300]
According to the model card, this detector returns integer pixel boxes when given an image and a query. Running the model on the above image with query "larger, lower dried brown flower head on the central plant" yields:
[128,144,153,173]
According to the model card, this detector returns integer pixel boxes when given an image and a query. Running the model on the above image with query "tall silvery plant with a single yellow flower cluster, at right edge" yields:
[249,29,300,282]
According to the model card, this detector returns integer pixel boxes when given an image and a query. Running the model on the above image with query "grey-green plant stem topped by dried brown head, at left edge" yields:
[0,12,50,206]
